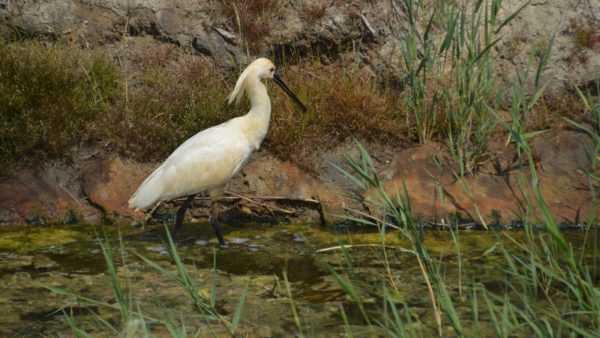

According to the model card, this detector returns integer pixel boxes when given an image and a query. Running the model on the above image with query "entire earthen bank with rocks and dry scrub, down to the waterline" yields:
[0,0,600,225]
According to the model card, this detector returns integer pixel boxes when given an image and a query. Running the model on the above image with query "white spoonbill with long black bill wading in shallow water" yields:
[129,58,306,245]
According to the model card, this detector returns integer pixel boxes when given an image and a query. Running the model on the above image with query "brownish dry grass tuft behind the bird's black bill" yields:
[265,63,407,169]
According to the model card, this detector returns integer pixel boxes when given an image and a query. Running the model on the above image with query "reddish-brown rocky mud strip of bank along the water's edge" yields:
[0,130,592,225]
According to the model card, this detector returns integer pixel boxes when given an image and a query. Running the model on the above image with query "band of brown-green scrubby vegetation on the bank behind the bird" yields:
[0,41,406,176]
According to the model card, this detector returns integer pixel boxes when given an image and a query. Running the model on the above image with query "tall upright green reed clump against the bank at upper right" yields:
[395,0,525,175]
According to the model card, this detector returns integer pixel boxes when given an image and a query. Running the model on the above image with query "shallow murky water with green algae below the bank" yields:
[0,223,598,336]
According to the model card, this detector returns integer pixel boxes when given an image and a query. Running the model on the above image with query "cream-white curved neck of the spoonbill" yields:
[245,78,271,149]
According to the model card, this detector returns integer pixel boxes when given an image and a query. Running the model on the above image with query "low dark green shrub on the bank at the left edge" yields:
[0,40,122,176]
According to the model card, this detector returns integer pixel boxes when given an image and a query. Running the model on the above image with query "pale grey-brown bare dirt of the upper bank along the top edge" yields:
[0,0,600,92]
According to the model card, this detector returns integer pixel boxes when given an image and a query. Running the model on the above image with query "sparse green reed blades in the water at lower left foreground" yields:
[39,225,250,337]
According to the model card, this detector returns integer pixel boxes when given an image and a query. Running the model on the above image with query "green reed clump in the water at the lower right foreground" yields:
[334,138,600,337]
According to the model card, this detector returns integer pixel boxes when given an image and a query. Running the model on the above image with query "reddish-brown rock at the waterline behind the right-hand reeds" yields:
[382,131,592,223]
